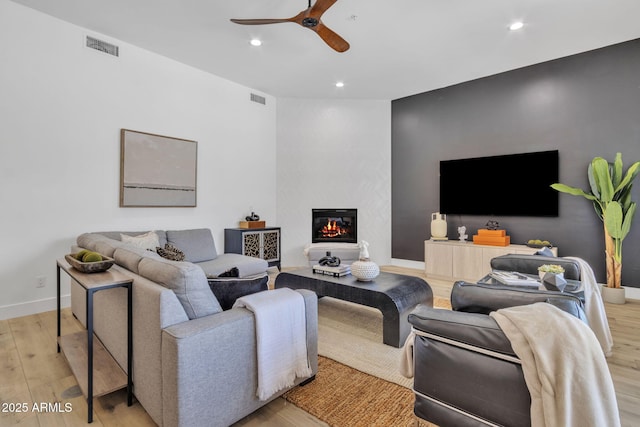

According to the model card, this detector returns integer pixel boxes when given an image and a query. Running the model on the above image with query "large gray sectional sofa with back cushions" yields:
[71,229,318,426]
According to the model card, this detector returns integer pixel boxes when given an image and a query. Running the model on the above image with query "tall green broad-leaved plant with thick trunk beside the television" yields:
[551,153,640,302]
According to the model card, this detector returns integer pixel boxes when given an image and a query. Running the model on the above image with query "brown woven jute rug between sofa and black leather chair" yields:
[283,356,435,427]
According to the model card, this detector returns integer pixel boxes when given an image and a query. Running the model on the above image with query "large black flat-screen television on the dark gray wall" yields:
[440,150,558,217]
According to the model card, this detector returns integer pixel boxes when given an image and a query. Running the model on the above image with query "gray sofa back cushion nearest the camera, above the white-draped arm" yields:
[138,257,222,319]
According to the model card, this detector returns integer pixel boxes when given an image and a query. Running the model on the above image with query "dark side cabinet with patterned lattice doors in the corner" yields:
[224,227,280,269]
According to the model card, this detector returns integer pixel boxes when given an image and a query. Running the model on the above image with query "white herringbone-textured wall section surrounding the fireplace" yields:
[277,99,391,266]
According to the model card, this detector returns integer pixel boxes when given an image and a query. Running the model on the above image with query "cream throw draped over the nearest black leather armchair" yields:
[491,303,620,427]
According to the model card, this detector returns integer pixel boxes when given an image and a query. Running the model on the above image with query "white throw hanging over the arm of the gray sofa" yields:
[233,288,312,400]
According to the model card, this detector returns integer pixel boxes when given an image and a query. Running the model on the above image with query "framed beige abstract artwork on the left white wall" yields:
[120,129,198,207]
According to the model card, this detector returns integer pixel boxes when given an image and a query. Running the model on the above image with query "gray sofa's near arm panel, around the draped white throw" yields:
[162,290,318,426]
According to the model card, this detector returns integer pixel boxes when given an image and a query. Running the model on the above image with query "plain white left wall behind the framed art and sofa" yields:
[0,0,276,318]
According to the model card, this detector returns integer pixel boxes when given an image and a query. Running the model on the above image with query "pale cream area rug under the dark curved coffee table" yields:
[318,297,451,388]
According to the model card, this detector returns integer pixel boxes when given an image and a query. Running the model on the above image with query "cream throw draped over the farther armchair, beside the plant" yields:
[565,257,613,357]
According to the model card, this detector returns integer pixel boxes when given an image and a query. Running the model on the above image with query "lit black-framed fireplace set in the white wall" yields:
[311,209,358,243]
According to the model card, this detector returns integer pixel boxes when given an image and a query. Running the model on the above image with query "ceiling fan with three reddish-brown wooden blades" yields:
[231,0,349,52]
